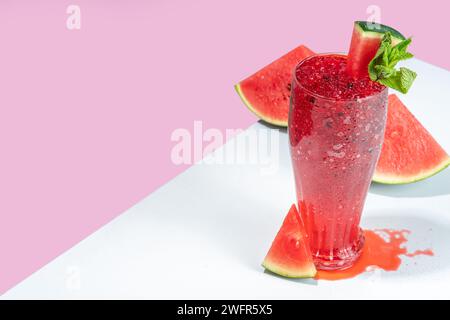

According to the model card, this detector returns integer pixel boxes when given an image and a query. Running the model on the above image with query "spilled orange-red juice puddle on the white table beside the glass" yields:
[315,229,434,280]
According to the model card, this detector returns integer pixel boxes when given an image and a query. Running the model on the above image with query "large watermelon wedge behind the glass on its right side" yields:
[373,94,450,184]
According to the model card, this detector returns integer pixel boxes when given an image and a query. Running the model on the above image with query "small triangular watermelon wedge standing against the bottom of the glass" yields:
[262,205,316,278]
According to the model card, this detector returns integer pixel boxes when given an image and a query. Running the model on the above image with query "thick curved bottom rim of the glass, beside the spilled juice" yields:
[313,229,364,271]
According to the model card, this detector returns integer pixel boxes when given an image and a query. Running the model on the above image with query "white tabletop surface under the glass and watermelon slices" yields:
[2,60,450,299]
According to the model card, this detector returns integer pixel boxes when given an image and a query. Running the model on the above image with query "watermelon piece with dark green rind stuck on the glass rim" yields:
[347,21,405,77]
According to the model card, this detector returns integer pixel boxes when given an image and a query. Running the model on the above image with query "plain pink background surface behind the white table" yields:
[0,0,450,293]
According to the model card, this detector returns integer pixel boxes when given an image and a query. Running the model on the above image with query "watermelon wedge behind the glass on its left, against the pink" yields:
[235,46,314,127]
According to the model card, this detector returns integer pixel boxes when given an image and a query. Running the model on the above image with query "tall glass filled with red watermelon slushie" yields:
[289,54,388,270]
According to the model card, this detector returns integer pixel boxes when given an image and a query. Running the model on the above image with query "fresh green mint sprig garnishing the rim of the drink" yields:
[369,32,417,93]
